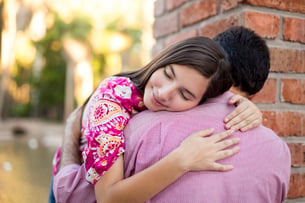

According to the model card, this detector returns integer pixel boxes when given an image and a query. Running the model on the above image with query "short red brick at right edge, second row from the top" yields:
[283,18,305,43]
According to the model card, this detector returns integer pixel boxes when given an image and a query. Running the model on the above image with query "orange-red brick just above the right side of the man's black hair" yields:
[245,12,280,39]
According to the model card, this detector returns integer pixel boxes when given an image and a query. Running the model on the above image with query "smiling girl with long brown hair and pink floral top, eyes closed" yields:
[52,37,262,202]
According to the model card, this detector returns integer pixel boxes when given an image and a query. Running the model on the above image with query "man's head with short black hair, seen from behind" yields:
[214,26,270,96]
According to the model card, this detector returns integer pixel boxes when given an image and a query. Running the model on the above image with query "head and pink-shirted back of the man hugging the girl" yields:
[124,27,291,203]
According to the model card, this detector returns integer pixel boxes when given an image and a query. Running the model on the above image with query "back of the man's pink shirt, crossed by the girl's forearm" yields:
[124,93,290,203]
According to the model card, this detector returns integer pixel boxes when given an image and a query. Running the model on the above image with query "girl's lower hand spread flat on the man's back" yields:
[177,129,239,171]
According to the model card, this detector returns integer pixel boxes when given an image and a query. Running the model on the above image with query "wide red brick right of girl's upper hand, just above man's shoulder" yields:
[262,111,305,136]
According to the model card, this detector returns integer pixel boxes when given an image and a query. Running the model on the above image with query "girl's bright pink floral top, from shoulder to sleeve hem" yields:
[81,77,146,184]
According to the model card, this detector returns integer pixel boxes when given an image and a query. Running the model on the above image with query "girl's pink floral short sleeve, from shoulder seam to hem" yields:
[83,99,130,184]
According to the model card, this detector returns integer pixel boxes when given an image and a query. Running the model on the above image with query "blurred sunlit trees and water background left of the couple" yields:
[0,0,154,202]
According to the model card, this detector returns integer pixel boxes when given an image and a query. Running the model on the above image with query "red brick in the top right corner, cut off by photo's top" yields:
[245,0,305,13]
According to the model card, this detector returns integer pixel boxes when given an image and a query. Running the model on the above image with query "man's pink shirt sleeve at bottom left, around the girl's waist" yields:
[53,164,96,203]
